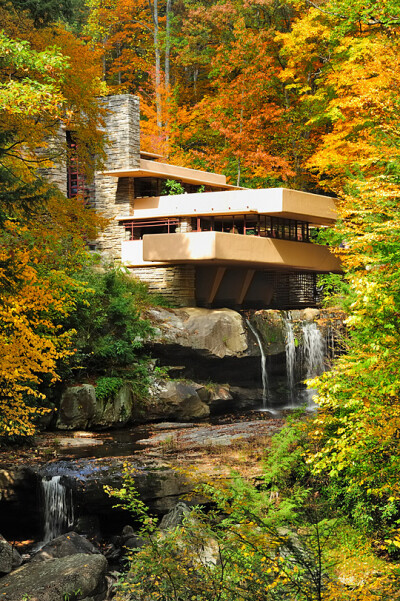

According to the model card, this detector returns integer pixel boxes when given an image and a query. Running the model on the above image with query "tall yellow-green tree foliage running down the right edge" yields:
[274,2,400,552]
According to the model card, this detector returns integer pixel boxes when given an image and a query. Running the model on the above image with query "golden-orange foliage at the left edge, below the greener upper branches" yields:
[0,222,89,436]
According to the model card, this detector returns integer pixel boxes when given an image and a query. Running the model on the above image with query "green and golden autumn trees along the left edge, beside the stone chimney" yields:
[0,10,101,438]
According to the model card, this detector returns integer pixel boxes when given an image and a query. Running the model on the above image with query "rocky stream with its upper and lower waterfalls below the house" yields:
[0,312,338,547]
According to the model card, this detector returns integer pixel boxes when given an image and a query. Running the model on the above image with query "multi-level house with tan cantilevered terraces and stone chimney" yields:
[46,94,340,309]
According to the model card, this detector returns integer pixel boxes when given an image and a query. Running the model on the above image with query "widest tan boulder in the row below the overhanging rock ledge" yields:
[147,380,210,422]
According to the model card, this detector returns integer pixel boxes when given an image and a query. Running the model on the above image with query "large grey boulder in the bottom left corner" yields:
[0,553,108,601]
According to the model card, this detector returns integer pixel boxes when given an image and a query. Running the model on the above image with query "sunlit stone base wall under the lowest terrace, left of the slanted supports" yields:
[129,265,196,307]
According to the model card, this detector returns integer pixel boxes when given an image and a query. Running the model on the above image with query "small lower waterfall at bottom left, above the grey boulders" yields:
[42,476,74,543]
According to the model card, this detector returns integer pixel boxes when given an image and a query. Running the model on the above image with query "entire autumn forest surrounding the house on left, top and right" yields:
[0,0,400,599]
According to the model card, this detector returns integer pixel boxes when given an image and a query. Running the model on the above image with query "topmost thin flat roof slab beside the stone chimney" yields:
[102,159,243,190]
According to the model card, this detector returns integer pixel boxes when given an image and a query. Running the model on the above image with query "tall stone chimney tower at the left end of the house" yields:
[93,94,140,259]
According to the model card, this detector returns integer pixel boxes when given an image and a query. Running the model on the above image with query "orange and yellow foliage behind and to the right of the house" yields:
[81,0,400,584]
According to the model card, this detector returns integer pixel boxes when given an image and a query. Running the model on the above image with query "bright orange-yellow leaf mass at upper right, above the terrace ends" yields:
[308,32,398,188]
